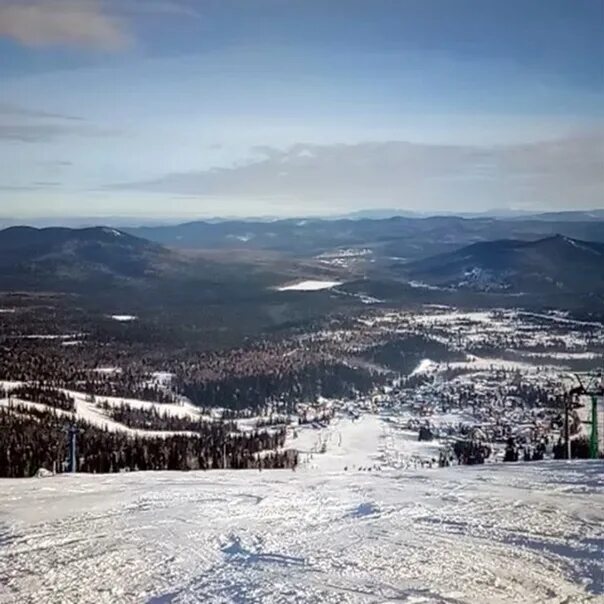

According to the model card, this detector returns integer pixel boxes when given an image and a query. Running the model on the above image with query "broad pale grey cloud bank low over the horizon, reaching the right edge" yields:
[115,134,604,209]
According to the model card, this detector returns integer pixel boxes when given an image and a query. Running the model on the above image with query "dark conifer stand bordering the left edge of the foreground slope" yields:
[0,404,298,478]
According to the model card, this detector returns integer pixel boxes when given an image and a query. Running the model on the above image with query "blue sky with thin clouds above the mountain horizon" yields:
[0,0,604,222]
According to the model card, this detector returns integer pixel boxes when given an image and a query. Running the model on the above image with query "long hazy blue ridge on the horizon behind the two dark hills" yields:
[125,213,604,259]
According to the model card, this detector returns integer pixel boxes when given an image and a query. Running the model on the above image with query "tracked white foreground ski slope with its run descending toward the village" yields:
[0,415,604,604]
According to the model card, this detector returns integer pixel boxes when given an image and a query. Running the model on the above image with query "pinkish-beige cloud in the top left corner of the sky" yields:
[0,0,198,51]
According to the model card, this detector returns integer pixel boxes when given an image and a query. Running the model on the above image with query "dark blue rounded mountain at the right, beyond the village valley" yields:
[399,235,604,294]
